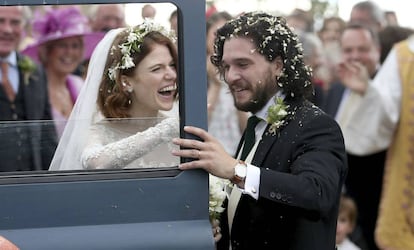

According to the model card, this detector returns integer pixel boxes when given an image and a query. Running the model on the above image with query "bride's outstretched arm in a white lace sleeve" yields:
[81,118,179,169]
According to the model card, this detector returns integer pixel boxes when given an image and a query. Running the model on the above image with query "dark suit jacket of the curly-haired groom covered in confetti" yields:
[219,97,347,250]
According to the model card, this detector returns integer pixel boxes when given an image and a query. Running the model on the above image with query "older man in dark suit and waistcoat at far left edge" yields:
[0,6,57,172]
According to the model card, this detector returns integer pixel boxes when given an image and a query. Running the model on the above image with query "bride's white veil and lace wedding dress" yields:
[49,29,179,170]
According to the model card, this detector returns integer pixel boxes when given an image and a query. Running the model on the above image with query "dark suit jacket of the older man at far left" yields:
[0,54,57,172]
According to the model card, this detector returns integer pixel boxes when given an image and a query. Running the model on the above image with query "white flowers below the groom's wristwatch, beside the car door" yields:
[208,174,230,221]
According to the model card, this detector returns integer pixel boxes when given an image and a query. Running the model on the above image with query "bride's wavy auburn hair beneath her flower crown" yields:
[97,29,178,118]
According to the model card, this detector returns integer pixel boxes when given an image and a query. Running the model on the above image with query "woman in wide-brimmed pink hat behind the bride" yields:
[22,7,103,137]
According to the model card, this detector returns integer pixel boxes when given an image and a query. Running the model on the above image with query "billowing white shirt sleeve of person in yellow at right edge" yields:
[341,36,414,155]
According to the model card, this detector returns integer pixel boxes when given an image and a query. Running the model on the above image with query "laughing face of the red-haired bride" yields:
[128,44,177,116]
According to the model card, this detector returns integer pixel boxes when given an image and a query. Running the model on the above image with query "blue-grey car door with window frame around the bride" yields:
[0,0,214,250]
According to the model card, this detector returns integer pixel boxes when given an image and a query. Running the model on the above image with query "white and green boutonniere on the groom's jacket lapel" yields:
[267,97,289,135]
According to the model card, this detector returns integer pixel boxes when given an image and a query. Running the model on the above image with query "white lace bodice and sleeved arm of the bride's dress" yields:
[81,118,179,169]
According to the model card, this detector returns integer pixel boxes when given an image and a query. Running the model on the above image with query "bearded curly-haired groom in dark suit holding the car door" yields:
[173,13,347,250]
